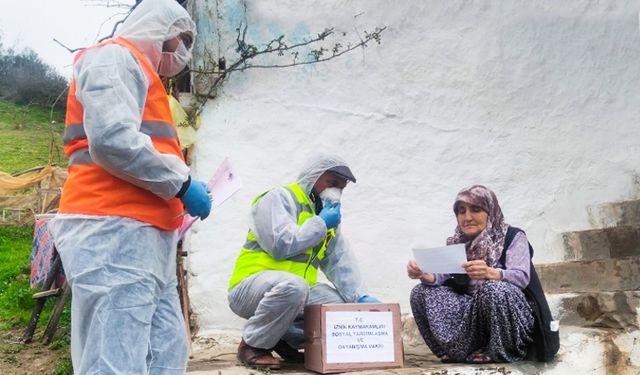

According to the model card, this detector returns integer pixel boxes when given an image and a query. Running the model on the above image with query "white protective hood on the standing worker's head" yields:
[114,0,196,70]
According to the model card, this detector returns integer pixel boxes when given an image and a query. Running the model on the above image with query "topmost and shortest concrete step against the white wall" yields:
[587,200,640,228]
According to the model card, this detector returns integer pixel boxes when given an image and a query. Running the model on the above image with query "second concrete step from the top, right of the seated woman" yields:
[562,225,640,260]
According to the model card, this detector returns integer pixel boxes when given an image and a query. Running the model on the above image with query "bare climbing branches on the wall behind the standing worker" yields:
[70,0,387,159]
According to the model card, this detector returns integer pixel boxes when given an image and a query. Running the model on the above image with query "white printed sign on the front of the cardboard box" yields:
[325,311,395,363]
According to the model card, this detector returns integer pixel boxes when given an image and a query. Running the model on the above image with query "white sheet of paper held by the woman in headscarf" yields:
[413,243,467,273]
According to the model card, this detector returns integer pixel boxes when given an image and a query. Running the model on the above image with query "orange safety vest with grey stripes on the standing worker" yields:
[58,37,184,230]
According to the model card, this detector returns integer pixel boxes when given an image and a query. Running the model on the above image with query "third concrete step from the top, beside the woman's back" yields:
[536,256,640,293]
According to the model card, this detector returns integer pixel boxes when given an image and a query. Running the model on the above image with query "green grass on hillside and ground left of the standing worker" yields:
[0,99,73,375]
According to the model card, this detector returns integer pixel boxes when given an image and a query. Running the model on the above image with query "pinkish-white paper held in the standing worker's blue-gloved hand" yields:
[178,158,242,238]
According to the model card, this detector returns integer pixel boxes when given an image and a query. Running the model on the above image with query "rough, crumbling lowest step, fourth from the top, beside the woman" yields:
[546,290,640,331]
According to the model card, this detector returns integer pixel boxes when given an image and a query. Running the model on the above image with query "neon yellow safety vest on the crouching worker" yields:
[229,184,335,289]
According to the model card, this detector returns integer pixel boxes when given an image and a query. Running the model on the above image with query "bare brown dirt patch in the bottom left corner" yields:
[0,329,63,375]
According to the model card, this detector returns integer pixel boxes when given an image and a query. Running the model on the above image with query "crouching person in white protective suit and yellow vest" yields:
[228,154,379,369]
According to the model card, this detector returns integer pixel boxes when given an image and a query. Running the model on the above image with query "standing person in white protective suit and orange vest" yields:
[49,0,211,374]
